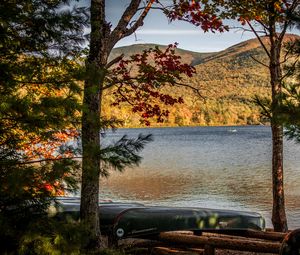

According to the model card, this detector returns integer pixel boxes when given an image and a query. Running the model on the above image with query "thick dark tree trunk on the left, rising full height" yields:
[80,0,107,249]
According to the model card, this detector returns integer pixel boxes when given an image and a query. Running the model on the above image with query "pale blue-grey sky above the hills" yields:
[81,0,298,52]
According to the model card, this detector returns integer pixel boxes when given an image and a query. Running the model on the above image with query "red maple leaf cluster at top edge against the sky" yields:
[164,0,229,32]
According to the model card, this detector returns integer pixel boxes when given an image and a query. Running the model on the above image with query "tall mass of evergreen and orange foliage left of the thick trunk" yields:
[0,0,87,254]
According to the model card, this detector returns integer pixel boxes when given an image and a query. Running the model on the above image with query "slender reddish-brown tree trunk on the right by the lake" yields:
[270,36,288,232]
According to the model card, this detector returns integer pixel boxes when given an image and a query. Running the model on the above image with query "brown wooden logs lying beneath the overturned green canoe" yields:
[120,230,286,255]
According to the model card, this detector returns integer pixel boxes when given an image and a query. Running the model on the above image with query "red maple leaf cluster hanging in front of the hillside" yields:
[111,44,195,126]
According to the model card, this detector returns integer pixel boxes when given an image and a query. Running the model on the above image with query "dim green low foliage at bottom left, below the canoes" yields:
[0,208,125,255]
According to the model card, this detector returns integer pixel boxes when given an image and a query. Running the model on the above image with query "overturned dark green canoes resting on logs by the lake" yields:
[56,198,265,239]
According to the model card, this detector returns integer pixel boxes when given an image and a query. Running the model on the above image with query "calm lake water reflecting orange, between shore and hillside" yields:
[101,126,300,229]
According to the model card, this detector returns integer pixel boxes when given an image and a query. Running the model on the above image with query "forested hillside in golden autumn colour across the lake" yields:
[103,35,295,127]
